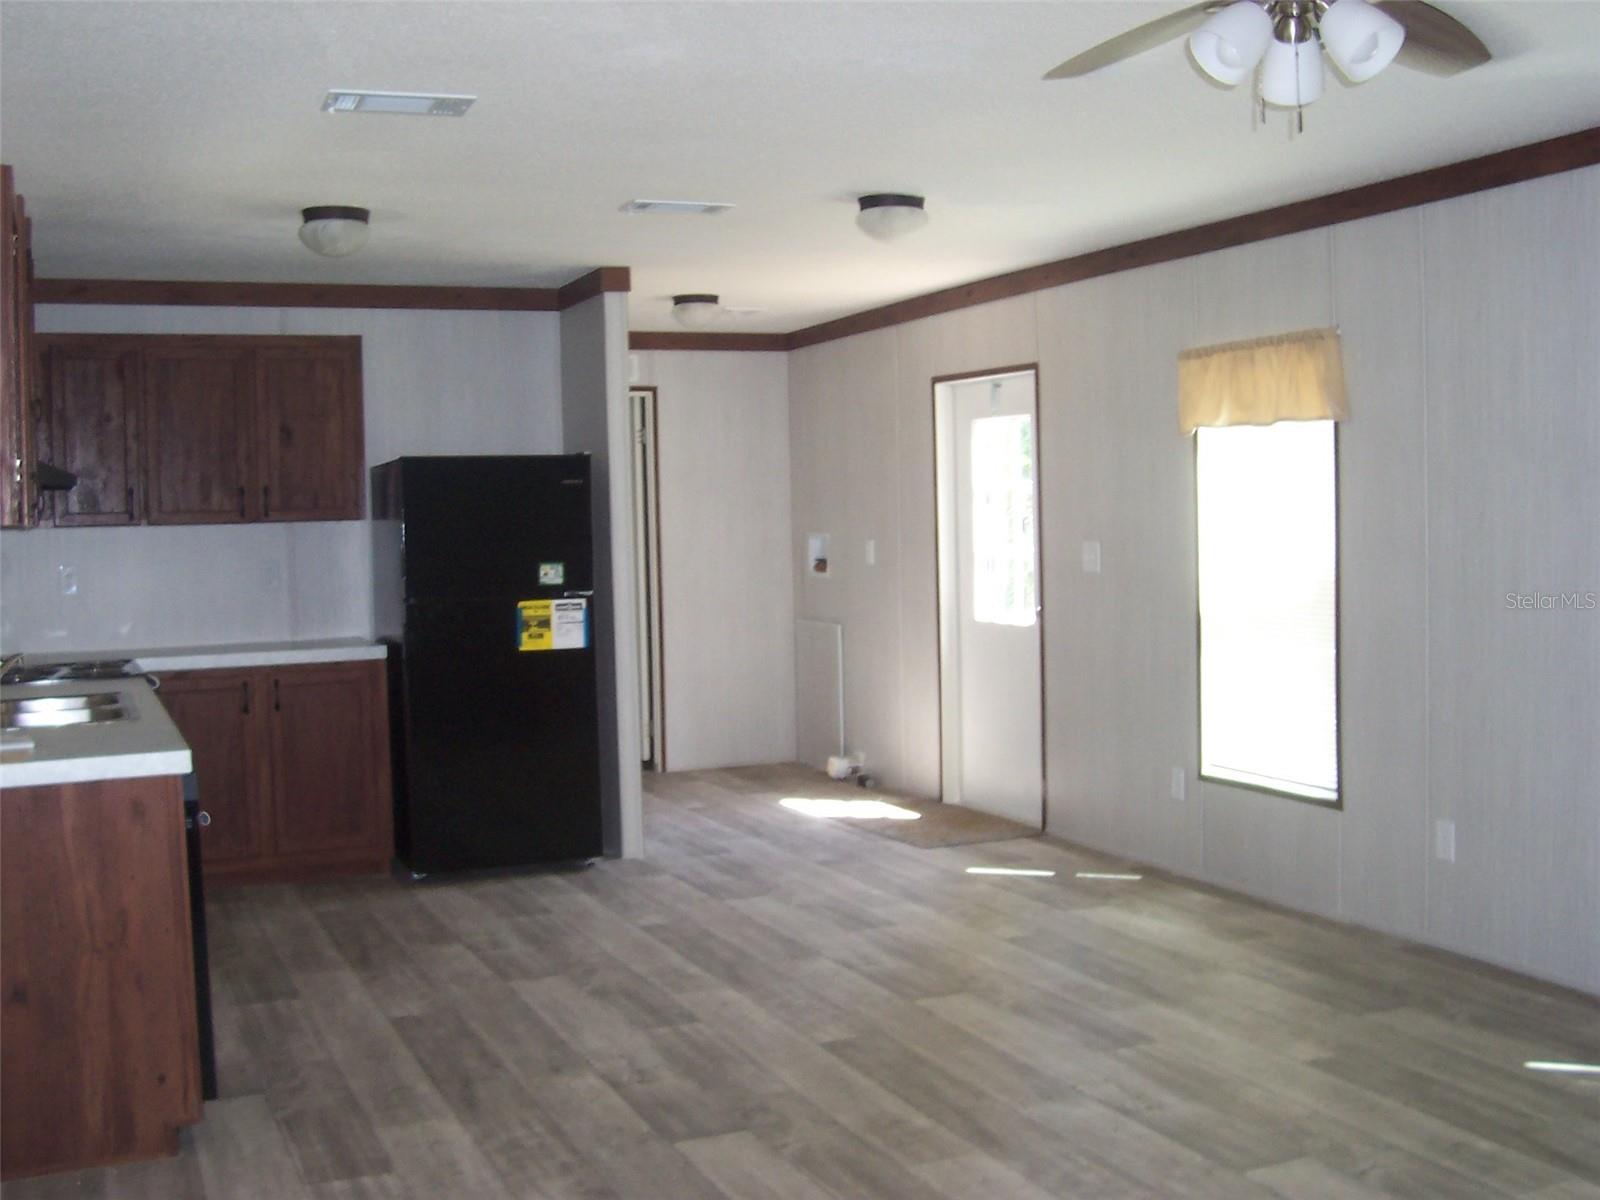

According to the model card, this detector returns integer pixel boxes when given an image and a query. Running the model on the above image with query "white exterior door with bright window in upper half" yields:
[934,370,1045,829]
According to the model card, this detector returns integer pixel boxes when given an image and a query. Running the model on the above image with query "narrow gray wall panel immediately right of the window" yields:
[1333,210,1429,938]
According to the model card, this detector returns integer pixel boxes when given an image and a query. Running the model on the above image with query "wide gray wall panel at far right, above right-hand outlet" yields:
[1422,168,1600,990]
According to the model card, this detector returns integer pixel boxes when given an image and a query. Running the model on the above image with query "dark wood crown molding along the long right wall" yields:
[787,126,1600,350]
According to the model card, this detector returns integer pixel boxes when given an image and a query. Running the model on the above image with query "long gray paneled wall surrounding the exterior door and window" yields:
[790,168,1600,990]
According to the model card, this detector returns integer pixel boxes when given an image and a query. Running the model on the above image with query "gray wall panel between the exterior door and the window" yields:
[1038,262,1203,874]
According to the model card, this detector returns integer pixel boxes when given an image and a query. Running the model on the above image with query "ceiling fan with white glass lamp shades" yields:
[1045,0,1490,109]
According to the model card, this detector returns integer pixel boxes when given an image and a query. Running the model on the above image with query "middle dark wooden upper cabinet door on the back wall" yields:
[142,344,259,525]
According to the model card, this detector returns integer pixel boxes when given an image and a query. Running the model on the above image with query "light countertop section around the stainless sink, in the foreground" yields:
[0,678,192,787]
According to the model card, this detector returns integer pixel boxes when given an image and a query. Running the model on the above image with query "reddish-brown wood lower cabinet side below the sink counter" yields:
[0,776,200,1179]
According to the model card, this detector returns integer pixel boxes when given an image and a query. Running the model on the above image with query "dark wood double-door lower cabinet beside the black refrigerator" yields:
[160,661,394,883]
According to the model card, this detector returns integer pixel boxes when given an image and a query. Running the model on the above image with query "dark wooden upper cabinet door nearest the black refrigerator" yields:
[256,338,365,522]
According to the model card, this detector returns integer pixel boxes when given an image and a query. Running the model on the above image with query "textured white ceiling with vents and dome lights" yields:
[0,0,1600,331]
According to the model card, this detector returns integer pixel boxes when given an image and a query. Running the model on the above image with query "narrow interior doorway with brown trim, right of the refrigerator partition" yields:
[627,387,667,771]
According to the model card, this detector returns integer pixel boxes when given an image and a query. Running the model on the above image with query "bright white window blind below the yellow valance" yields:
[1195,421,1339,802]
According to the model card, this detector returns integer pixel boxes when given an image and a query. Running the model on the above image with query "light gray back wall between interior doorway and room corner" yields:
[634,350,795,771]
